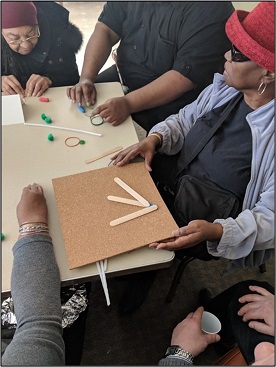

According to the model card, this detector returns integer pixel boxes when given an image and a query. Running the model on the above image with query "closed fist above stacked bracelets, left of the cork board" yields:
[16,183,48,226]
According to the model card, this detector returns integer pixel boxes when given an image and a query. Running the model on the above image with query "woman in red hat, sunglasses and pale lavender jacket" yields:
[112,2,275,269]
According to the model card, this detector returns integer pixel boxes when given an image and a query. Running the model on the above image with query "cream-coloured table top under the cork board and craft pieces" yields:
[2,83,174,293]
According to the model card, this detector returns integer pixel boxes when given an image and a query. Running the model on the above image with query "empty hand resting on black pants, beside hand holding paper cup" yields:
[238,285,275,336]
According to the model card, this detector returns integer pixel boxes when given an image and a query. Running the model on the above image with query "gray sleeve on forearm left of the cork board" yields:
[2,235,65,366]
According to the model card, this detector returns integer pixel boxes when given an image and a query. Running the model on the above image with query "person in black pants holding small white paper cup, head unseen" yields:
[159,280,275,366]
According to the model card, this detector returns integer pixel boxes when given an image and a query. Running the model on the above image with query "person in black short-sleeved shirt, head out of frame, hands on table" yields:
[67,1,234,131]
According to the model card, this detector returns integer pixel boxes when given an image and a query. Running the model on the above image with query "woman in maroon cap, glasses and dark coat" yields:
[1,1,82,97]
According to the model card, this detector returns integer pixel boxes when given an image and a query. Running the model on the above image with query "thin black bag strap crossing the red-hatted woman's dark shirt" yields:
[177,93,243,176]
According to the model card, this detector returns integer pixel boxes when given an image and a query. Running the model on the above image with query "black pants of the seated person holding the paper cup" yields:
[206,280,275,365]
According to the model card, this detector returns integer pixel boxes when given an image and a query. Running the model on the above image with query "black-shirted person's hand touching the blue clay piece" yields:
[66,79,97,106]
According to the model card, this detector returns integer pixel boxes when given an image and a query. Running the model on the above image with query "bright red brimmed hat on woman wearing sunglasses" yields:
[225,1,275,72]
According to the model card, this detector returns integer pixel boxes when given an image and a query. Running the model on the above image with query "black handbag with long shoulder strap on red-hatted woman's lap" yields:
[174,93,242,226]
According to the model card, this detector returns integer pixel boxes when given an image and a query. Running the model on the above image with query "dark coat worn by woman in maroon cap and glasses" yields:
[1,1,83,88]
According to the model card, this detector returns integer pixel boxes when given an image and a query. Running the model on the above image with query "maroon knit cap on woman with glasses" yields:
[1,1,38,29]
